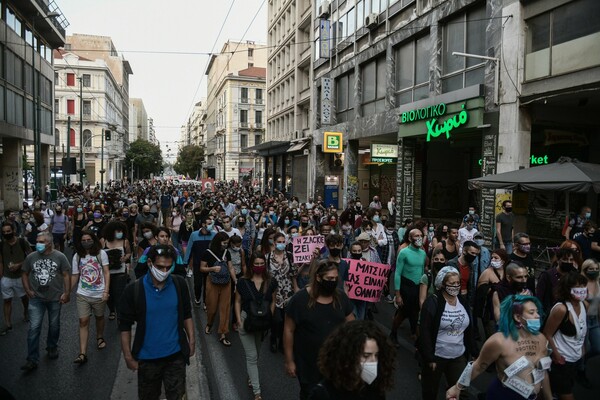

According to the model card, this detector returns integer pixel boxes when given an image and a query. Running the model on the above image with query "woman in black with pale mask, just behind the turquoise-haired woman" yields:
[473,249,510,338]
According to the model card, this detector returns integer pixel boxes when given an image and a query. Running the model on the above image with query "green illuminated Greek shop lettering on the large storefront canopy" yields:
[401,103,469,142]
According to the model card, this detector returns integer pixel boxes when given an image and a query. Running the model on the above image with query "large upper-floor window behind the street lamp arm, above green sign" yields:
[442,7,488,92]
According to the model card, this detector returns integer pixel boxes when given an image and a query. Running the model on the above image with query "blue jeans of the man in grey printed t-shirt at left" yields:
[27,297,61,363]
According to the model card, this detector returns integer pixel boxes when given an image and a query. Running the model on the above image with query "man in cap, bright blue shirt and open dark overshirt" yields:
[118,245,196,399]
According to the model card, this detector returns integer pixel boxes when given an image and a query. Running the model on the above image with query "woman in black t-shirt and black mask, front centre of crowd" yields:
[284,260,354,400]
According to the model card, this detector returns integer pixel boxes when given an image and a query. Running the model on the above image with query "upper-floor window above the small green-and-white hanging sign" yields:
[362,56,387,116]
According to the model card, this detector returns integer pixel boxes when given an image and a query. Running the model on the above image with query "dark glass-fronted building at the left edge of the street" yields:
[0,0,68,210]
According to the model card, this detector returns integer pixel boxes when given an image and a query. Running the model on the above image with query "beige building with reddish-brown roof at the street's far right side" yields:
[205,41,267,184]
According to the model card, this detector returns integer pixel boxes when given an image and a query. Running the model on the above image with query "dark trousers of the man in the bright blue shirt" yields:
[138,353,185,400]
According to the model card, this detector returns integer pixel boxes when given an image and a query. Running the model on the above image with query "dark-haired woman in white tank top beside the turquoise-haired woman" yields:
[544,271,587,400]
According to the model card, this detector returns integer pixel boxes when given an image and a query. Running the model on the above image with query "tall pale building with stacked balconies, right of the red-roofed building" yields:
[256,0,314,198]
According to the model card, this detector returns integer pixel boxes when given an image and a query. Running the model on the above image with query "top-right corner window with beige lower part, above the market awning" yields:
[525,0,600,80]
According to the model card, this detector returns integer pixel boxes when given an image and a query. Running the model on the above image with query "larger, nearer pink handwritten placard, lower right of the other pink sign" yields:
[346,259,390,303]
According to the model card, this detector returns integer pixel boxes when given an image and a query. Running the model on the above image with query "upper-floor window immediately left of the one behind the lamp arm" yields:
[394,36,431,106]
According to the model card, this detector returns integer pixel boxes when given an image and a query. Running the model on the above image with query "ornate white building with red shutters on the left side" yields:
[54,51,129,184]
